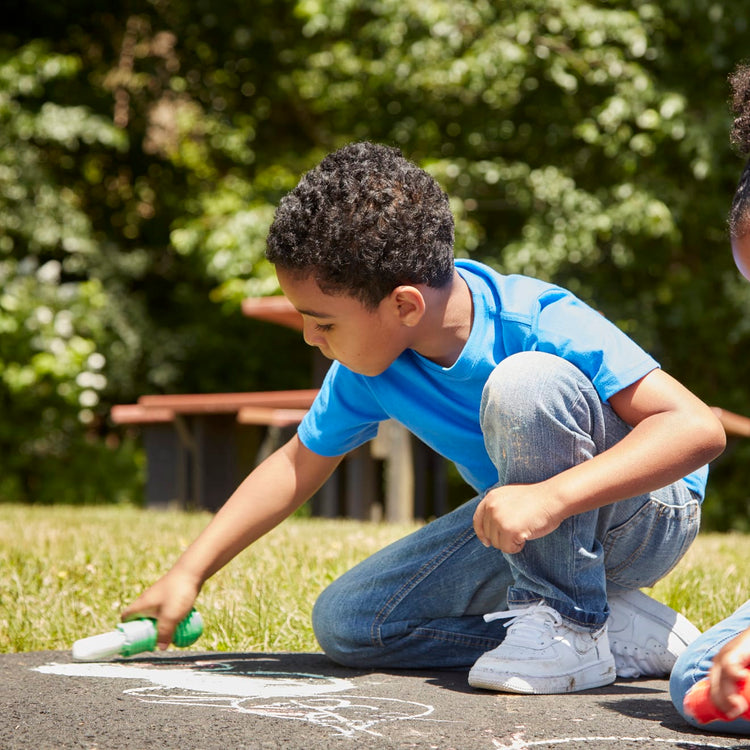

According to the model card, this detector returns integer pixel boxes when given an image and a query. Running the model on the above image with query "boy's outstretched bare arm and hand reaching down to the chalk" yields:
[122,435,342,649]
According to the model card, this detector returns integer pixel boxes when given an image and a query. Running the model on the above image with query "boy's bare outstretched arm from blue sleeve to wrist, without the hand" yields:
[173,436,340,588]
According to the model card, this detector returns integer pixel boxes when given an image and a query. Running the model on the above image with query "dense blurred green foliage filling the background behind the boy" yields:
[0,0,750,528]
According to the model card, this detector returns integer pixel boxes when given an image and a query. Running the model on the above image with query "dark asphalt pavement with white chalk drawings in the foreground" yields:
[0,651,750,750]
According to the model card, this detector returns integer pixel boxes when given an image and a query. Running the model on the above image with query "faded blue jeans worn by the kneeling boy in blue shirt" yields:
[313,352,700,669]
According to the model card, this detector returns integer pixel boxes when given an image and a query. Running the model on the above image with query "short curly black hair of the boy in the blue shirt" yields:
[266,142,453,309]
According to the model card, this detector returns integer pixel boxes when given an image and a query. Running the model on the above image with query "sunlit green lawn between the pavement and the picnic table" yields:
[0,504,750,652]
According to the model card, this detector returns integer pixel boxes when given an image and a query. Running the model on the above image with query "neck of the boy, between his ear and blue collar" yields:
[411,271,474,367]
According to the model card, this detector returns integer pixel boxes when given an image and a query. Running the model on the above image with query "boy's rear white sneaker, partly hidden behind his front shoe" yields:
[607,591,701,677]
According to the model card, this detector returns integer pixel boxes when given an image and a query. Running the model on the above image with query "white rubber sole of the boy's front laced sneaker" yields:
[469,659,616,695]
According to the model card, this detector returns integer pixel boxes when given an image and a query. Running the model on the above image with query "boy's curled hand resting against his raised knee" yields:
[474,484,564,555]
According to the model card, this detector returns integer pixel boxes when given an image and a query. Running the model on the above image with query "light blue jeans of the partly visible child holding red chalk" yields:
[669,601,750,735]
